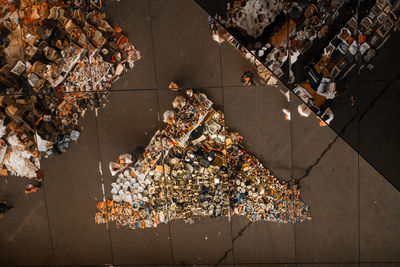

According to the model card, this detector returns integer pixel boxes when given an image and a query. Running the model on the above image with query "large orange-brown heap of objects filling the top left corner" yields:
[0,0,140,178]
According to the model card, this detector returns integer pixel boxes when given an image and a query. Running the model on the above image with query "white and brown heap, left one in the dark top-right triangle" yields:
[217,0,300,78]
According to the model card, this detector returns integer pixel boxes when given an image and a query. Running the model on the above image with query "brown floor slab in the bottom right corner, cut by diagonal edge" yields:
[360,157,400,266]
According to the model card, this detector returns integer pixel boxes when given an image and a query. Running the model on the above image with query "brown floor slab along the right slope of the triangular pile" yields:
[224,86,292,180]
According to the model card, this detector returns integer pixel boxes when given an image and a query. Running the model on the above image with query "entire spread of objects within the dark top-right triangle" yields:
[213,0,400,125]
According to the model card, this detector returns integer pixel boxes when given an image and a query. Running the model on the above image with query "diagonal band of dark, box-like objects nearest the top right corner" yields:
[292,0,400,124]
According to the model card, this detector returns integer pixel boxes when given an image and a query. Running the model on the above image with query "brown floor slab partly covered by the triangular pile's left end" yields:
[97,90,172,265]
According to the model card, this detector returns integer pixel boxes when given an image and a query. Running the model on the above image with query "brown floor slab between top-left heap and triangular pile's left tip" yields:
[42,112,112,265]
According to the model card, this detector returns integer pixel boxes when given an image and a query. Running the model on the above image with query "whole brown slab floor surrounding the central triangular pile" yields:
[0,0,400,267]
